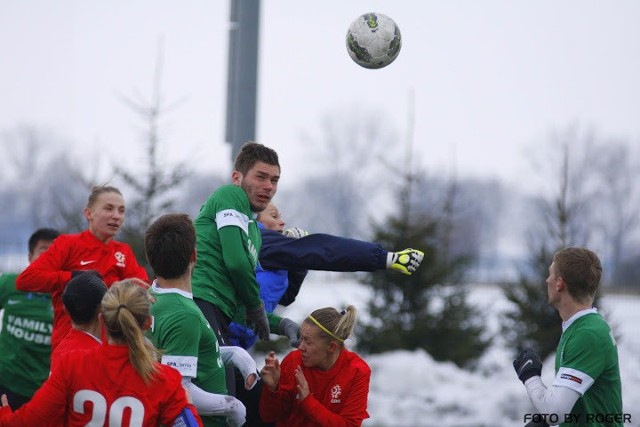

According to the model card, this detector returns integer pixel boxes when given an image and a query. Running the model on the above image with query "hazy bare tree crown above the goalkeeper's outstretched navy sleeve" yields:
[278,110,397,238]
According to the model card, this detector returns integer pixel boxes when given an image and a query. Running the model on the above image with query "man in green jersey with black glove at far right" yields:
[513,247,629,426]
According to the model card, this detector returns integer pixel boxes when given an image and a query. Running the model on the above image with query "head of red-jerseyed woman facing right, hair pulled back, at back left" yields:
[84,192,125,242]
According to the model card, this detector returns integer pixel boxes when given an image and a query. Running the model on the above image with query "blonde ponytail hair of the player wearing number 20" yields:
[102,279,158,383]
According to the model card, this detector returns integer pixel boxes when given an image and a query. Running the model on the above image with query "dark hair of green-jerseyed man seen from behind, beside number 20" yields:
[144,214,196,279]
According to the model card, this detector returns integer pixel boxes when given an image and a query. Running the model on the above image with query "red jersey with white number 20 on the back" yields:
[0,344,202,427]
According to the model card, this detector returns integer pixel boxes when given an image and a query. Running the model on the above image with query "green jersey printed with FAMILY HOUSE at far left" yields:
[0,273,53,397]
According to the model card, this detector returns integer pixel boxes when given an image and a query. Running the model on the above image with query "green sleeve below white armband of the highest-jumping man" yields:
[218,226,262,310]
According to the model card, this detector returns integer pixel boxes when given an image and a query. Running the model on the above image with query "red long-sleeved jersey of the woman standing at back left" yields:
[16,230,149,349]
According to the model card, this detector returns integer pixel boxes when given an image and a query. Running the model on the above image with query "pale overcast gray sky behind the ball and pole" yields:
[0,0,640,194]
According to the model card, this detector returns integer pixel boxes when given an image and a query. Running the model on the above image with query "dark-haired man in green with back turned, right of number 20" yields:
[144,214,258,426]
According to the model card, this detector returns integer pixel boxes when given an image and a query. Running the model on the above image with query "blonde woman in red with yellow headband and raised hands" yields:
[260,305,371,427]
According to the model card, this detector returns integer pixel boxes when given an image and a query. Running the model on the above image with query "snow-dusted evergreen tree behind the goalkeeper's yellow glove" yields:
[357,179,490,367]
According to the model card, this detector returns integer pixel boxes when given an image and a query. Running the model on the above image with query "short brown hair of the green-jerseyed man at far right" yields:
[553,247,602,302]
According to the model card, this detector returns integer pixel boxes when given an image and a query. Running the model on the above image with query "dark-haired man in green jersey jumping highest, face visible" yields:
[193,142,280,345]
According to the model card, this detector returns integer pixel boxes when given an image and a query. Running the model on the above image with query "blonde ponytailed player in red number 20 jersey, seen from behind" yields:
[0,280,202,427]
